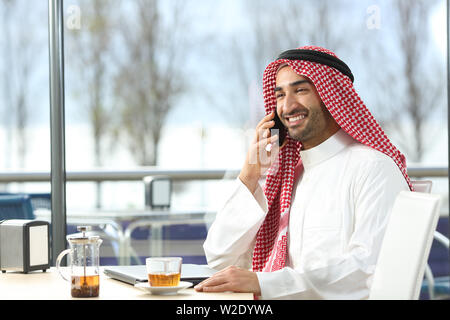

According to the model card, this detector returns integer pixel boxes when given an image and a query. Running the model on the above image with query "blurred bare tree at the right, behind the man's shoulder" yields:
[371,0,445,162]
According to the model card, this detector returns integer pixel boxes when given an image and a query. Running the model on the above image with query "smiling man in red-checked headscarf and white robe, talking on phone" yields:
[196,46,412,299]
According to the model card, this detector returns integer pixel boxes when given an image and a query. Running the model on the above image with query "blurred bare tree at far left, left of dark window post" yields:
[1,0,43,168]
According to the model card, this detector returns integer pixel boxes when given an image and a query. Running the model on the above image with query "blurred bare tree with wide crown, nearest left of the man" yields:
[115,0,189,166]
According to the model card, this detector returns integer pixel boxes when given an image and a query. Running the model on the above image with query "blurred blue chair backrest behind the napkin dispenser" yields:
[0,195,35,220]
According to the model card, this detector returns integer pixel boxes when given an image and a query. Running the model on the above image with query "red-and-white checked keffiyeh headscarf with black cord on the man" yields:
[253,46,413,272]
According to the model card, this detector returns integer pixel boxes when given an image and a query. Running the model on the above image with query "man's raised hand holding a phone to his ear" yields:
[239,111,287,194]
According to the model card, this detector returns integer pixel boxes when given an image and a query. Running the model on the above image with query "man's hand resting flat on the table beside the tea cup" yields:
[194,266,261,295]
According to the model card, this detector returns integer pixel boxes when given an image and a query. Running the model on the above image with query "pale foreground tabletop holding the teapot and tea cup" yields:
[0,267,253,300]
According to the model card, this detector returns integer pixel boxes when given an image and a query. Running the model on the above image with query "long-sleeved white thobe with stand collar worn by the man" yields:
[203,130,409,299]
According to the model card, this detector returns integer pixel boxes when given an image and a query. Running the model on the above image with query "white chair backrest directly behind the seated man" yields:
[369,191,441,300]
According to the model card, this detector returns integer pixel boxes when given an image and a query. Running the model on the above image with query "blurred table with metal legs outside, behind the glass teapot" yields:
[35,210,216,265]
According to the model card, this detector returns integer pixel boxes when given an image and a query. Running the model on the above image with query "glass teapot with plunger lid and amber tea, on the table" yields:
[56,226,103,298]
